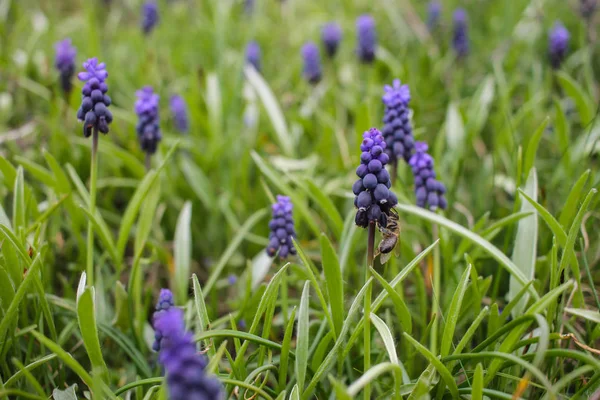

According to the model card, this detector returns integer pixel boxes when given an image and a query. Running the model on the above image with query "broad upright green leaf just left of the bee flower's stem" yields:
[321,234,345,337]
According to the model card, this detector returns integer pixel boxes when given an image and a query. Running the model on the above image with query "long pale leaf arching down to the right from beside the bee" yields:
[396,204,539,299]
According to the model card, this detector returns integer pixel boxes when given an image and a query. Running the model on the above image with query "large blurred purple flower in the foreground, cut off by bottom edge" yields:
[154,307,224,400]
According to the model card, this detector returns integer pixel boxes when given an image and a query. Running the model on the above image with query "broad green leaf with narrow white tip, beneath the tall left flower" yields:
[76,272,108,377]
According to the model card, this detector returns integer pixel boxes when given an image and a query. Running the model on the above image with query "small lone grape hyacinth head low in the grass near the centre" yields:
[267,195,296,260]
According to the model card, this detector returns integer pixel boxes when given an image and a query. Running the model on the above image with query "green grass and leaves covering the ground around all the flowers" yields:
[0,0,600,400]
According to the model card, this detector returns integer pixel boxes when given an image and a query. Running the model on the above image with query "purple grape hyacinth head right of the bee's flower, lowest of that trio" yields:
[409,142,448,211]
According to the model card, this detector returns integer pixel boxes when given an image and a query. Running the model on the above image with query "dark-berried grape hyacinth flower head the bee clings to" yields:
[352,128,398,228]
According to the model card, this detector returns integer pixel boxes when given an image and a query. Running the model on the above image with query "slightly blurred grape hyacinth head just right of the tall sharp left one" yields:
[135,86,162,154]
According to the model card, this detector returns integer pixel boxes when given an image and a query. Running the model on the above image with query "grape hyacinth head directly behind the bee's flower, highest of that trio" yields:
[382,79,415,164]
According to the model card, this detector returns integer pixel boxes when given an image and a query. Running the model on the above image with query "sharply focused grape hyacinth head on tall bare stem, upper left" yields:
[77,57,112,137]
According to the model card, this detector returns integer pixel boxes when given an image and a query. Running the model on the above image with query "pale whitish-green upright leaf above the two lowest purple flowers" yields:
[173,201,192,304]
